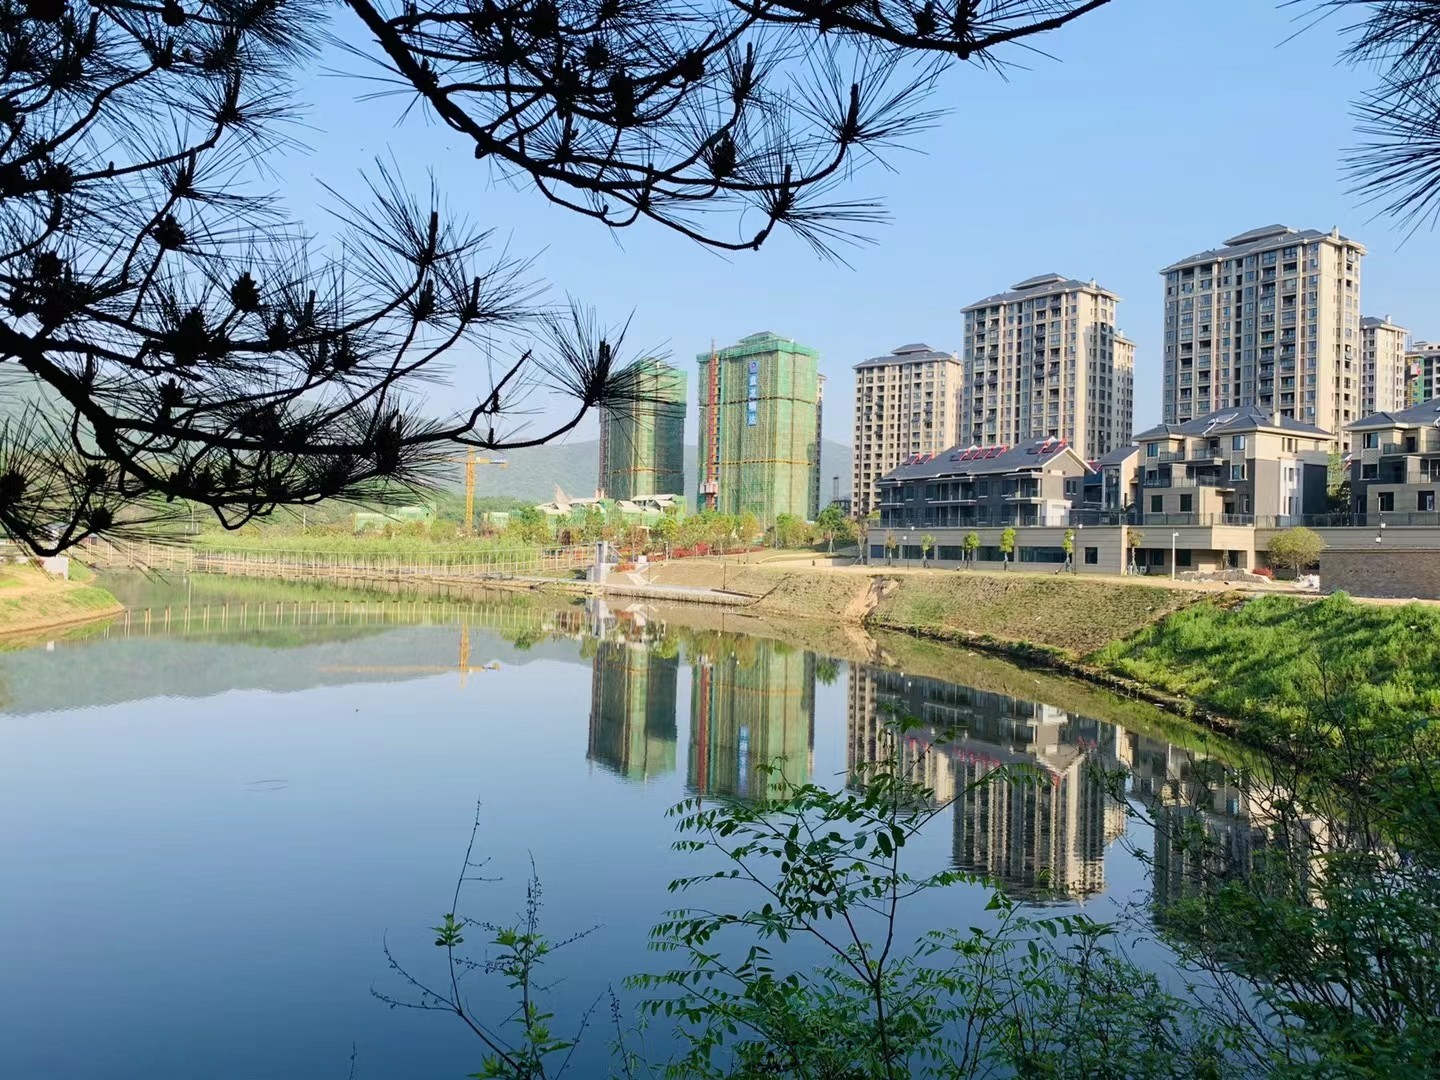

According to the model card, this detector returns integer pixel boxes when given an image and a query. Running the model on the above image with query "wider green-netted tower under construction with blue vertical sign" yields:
[697,333,821,524]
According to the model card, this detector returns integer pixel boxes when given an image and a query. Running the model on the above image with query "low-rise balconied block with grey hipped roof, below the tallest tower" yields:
[1135,406,1333,526]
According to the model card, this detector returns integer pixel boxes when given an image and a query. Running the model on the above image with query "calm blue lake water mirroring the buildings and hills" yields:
[0,577,1246,1080]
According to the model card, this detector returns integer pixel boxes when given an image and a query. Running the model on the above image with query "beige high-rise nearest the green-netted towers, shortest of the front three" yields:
[851,344,965,517]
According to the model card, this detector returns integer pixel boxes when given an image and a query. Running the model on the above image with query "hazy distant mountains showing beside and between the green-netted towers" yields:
[443,439,851,503]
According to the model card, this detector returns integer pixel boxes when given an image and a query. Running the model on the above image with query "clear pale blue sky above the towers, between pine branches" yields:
[279,0,1440,442]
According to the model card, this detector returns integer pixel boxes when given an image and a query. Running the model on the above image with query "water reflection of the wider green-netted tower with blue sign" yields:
[690,639,815,799]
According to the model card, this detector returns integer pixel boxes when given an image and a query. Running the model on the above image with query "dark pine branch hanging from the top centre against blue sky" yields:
[347,0,1109,253]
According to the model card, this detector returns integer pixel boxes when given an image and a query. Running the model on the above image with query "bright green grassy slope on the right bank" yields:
[1090,595,1440,726]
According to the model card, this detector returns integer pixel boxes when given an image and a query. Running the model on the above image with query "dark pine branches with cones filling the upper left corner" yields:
[0,0,659,554]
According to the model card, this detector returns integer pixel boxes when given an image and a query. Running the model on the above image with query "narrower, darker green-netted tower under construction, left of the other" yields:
[599,360,685,500]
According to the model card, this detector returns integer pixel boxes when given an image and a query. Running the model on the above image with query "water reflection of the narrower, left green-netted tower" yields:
[586,641,680,780]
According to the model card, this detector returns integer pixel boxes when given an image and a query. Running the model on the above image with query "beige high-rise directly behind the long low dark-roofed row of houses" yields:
[959,274,1135,458]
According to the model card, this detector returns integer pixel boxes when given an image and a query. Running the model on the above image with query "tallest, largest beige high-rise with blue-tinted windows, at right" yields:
[1161,225,1365,444]
